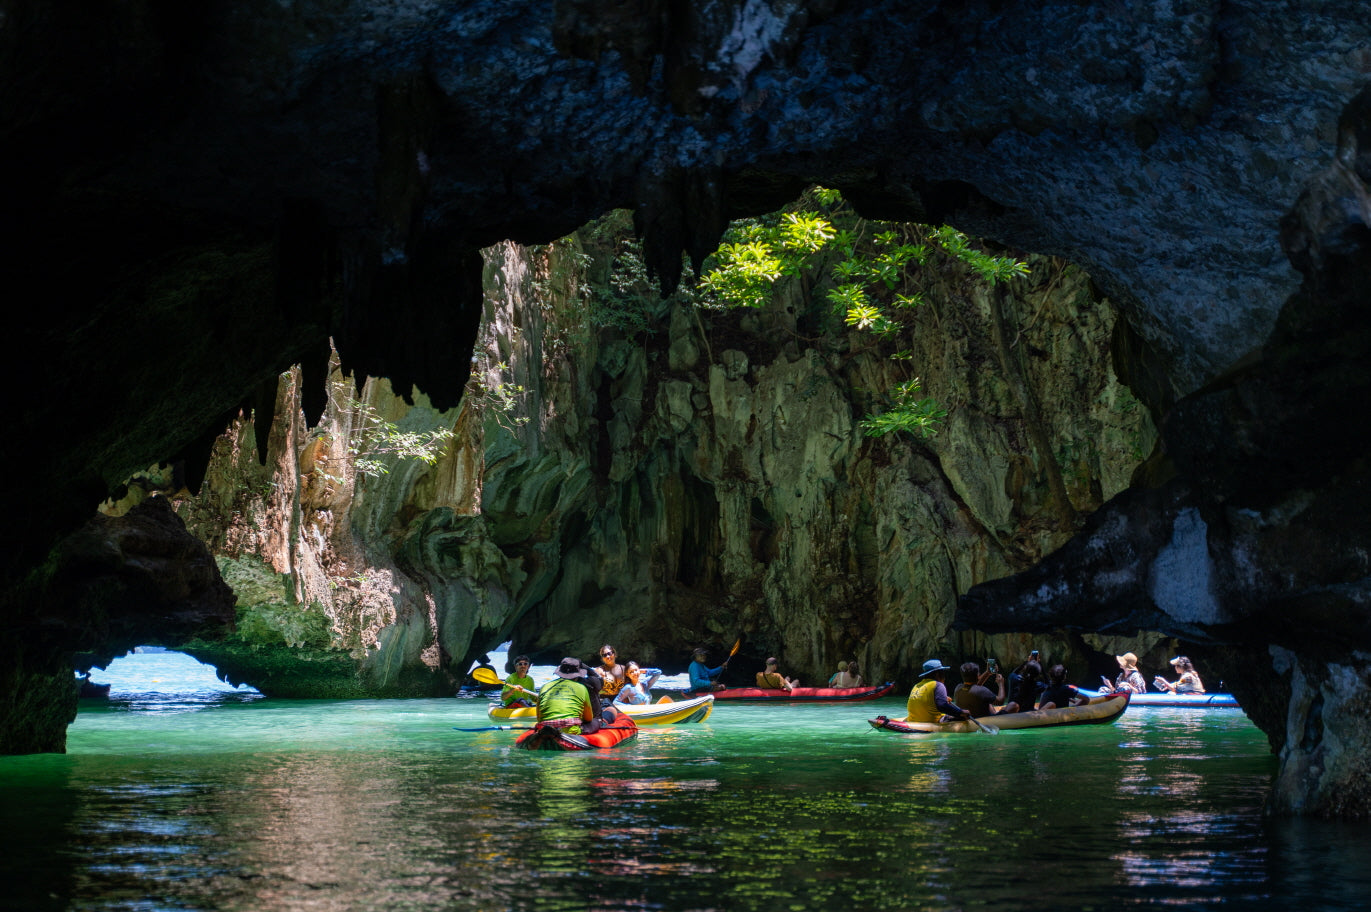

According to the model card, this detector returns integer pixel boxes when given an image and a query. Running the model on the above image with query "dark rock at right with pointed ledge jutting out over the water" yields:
[962,91,1371,816]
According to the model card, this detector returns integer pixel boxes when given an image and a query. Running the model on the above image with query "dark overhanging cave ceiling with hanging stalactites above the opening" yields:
[8,0,1371,813]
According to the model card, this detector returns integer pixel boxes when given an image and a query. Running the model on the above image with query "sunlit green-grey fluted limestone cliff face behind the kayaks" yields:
[171,218,1156,695]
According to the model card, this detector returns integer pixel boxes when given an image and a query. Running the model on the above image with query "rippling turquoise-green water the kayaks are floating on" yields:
[0,656,1371,912]
